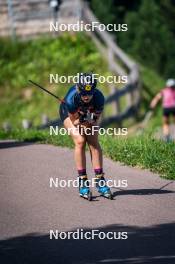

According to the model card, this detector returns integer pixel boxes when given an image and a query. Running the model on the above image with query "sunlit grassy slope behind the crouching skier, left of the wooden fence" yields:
[0,33,109,128]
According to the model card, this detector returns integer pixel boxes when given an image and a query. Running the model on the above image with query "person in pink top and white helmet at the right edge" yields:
[150,79,175,141]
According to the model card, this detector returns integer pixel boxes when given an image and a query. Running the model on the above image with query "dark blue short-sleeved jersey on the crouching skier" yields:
[64,86,105,114]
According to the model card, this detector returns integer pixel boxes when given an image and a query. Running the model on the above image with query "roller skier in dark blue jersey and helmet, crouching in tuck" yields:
[59,73,112,200]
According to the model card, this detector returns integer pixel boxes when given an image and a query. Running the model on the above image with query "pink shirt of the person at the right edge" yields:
[161,87,175,108]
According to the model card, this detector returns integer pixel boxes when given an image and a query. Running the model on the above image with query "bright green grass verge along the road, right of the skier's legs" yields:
[101,135,175,179]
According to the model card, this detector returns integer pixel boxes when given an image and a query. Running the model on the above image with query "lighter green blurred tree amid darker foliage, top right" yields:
[119,0,175,76]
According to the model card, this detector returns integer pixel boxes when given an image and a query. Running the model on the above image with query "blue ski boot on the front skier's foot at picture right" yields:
[95,173,113,200]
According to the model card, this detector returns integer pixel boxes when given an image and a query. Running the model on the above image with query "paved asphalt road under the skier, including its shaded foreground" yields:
[0,142,175,264]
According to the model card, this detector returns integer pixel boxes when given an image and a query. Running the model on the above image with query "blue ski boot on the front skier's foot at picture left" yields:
[79,175,92,201]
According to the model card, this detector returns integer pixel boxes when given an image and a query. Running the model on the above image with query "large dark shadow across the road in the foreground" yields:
[0,223,175,264]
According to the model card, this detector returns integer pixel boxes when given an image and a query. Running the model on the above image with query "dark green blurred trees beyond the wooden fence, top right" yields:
[89,0,175,78]
